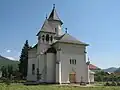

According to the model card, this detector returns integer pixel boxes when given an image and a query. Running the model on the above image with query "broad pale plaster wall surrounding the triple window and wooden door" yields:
[60,44,88,83]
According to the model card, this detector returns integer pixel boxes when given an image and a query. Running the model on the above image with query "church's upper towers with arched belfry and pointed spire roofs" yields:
[37,4,63,44]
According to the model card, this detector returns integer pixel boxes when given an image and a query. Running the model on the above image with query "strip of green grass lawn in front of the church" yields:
[0,84,120,90]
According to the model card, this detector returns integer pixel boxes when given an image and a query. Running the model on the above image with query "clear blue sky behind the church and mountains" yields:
[0,0,120,68]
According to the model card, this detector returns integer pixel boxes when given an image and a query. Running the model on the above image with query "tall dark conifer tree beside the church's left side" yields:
[19,40,29,78]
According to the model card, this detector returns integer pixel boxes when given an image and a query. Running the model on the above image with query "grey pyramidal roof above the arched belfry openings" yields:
[37,19,55,36]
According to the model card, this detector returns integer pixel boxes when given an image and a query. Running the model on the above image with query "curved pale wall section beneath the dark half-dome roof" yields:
[46,53,56,83]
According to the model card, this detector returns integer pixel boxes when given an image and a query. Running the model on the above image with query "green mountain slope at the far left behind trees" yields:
[0,55,19,69]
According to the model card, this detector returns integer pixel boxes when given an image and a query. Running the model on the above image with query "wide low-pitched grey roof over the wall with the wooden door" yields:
[53,33,88,46]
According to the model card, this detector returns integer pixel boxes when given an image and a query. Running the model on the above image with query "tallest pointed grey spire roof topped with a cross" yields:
[48,4,63,24]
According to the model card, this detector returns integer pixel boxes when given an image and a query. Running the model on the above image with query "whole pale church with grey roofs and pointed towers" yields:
[27,5,89,84]
